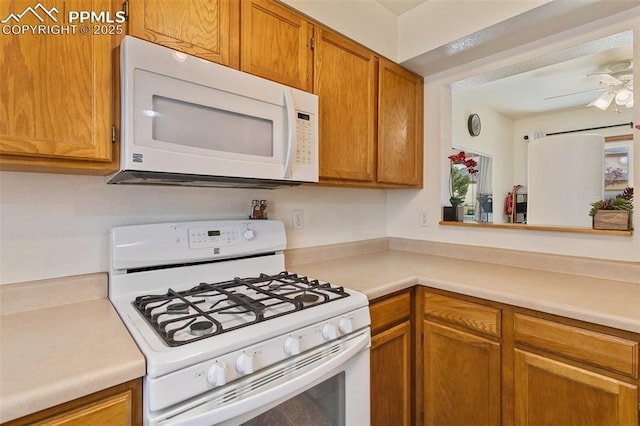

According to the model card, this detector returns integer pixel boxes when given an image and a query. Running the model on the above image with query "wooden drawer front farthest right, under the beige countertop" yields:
[514,314,638,378]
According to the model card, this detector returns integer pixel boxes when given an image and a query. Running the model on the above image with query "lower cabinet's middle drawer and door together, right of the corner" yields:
[422,291,501,426]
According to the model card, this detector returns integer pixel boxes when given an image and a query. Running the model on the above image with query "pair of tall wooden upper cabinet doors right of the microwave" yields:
[314,29,424,188]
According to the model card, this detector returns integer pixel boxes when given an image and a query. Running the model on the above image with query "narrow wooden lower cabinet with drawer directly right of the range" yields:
[371,290,413,426]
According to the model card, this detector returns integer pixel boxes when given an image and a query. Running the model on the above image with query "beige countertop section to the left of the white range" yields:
[0,273,145,422]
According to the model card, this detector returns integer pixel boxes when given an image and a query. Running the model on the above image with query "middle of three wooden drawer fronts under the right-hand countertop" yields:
[424,292,502,337]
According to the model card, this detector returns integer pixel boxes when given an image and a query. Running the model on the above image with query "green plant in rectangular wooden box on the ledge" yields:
[589,188,633,231]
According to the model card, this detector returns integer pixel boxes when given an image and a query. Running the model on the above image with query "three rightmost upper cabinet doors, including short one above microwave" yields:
[240,0,423,188]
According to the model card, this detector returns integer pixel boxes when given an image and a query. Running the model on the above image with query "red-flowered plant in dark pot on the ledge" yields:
[442,151,478,221]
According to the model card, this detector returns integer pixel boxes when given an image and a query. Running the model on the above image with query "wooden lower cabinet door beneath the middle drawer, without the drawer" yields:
[424,321,501,426]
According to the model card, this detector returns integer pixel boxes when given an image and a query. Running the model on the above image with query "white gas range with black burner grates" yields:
[109,220,370,425]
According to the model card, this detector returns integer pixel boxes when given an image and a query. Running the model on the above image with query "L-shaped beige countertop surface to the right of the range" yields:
[287,250,640,333]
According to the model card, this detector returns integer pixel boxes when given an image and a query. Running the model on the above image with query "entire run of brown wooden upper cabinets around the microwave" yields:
[0,0,423,188]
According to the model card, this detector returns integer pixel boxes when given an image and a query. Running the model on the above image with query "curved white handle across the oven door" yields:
[157,328,371,426]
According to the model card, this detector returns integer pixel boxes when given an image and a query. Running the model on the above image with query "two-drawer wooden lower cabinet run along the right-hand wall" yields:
[416,287,640,426]
